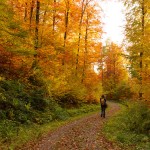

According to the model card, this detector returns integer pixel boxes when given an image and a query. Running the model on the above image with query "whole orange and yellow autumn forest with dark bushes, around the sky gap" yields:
[0,0,150,148]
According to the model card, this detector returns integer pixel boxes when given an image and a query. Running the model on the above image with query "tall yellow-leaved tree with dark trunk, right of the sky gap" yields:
[125,0,149,99]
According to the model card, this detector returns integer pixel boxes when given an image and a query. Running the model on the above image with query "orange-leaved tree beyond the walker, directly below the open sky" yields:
[99,43,130,100]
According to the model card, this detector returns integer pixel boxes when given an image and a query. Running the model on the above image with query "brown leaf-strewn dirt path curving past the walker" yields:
[24,103,122,150]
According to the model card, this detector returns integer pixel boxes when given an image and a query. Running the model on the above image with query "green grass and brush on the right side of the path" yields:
[104,102,150,150]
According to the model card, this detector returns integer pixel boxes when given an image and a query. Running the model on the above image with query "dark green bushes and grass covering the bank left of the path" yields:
[0,80,99,149]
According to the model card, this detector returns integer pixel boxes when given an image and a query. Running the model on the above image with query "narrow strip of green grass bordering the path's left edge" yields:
[0,105,99,150]
